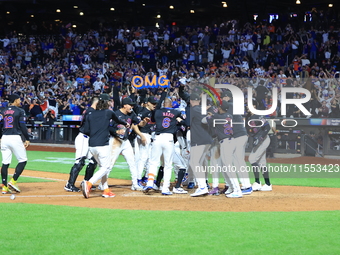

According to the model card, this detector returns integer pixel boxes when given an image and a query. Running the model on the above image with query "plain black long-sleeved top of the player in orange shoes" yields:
[84,109,127,147]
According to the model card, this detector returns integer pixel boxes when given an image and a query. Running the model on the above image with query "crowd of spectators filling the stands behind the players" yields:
[0,14,340,121]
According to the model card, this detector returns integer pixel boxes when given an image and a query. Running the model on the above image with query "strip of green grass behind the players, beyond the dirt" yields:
[0,151,340,188]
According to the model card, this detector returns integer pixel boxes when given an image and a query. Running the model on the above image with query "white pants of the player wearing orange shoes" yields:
[89,145,111,189]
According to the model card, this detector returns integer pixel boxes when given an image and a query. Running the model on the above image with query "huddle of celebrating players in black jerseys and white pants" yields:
[64,82,272,198]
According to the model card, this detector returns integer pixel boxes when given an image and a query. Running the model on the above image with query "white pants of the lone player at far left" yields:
[1,135,27,165]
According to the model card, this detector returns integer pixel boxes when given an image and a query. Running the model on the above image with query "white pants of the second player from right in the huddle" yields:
[233,135,251,189]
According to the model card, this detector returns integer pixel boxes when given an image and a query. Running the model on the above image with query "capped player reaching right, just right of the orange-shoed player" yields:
[110,97,150,191]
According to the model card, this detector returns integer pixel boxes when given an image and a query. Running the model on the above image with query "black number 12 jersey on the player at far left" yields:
[0,105,29,141]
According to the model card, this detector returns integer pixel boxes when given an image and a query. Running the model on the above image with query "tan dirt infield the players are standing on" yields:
[0,146,340,212]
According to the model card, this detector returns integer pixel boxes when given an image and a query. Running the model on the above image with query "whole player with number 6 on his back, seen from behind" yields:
[144,98,182,195]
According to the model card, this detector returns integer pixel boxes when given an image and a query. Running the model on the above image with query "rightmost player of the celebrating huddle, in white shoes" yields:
[247,100,272,191]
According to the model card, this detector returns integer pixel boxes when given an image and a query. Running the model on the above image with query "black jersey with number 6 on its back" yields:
[155,108,181,134]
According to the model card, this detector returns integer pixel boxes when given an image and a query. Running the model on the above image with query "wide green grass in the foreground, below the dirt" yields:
[1,204,340,255]
